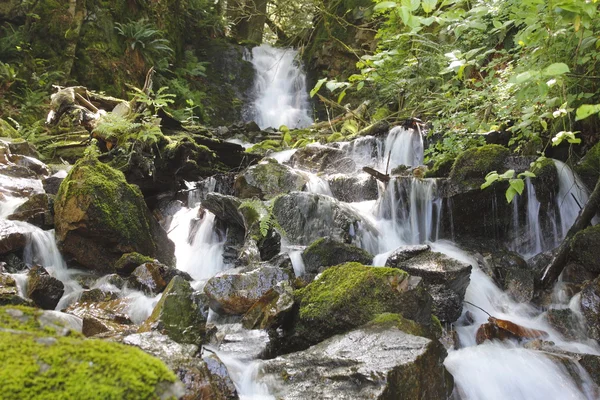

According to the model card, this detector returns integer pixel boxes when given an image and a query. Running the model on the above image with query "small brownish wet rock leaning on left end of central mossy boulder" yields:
[242,281,294,329]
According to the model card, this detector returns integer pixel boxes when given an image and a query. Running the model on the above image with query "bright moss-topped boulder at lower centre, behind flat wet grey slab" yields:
[294,263,432,344]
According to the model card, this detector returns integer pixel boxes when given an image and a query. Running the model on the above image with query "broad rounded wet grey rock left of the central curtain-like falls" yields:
[273,192,374,246]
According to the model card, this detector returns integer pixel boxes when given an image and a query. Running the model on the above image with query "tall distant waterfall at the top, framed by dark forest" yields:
[251,44,312,129]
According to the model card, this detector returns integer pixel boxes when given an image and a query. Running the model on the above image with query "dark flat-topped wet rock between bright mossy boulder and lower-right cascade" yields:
[385,246,471,322]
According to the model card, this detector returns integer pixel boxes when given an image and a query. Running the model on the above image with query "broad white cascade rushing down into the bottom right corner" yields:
[431,241,600,400]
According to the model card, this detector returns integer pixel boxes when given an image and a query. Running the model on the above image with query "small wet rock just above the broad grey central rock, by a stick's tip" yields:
[327,174,378,203]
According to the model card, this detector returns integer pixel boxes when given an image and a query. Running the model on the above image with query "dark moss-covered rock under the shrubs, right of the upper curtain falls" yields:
[450,144,510,186]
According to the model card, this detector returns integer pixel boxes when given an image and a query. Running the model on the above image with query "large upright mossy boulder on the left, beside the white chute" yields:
[54,156,175,272]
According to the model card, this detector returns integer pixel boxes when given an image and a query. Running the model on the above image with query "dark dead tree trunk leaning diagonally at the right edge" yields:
[541,179,600,289]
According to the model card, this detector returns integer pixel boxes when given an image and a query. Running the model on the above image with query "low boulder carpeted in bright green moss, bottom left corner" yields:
[0,307,183,400]
